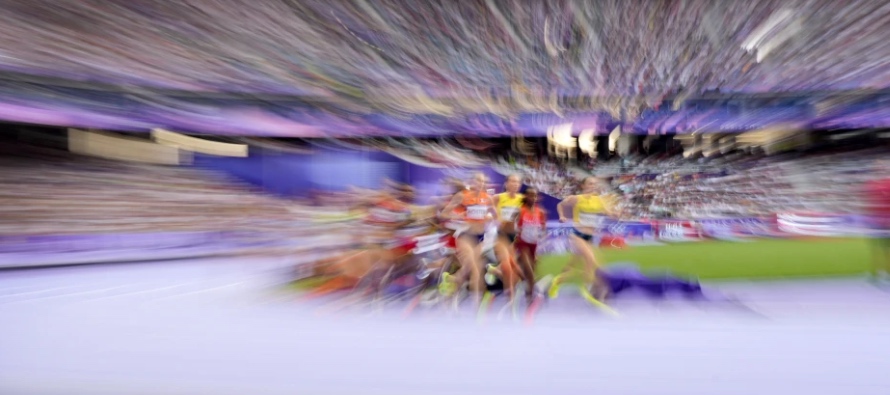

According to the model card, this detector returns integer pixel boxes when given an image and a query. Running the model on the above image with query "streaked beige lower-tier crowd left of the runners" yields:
[0,144,440,259]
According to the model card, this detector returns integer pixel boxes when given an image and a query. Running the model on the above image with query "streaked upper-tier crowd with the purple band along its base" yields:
[0,0,890,137]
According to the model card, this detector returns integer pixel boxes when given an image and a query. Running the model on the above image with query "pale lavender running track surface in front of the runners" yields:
[0,259,890,395]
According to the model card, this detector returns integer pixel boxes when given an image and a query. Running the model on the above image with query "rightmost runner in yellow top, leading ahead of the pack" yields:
[550,177,615,296]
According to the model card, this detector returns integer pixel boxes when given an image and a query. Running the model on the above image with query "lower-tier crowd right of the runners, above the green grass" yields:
[497,150,890,219]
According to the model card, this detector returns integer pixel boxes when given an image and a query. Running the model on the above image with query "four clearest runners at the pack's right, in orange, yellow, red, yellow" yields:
[439,173,615,301]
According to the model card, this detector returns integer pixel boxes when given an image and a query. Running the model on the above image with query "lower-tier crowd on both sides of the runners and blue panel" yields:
[0,141,890,240]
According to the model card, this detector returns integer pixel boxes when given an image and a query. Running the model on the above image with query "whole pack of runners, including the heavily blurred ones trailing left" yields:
[302,173,615,302]
